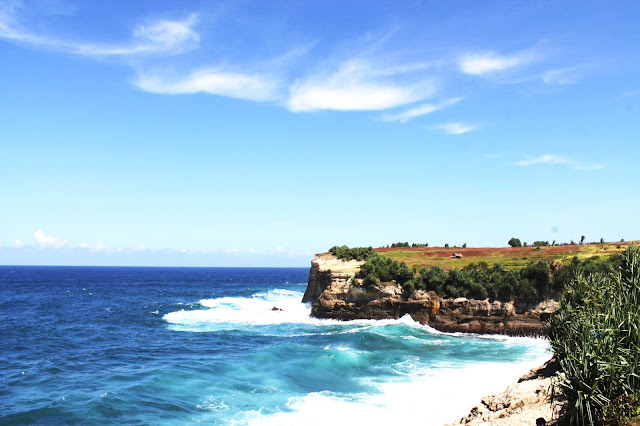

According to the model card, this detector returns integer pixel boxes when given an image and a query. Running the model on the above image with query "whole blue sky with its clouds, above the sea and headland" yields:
[0,0,640,266]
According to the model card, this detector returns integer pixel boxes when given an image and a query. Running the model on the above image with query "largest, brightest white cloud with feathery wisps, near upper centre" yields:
[286,60,436,112]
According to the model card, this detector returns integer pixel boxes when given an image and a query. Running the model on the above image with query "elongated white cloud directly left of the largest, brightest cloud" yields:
[134,68,278,101]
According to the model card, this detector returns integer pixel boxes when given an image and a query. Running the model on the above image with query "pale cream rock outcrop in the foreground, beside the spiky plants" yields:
[444,359,566,426]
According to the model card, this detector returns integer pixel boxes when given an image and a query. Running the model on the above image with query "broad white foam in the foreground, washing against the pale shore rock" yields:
[238,350,549,426]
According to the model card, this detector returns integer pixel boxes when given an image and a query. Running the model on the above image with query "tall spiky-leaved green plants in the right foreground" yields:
[546,245,640,425]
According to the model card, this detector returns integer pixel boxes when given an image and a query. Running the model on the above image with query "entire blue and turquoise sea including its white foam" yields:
[0,266,550,425]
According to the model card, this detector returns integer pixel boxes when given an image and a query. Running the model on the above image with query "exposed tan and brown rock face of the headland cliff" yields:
[302,253,557,335]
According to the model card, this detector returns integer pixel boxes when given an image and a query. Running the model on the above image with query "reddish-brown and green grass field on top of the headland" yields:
[375,242,638,270]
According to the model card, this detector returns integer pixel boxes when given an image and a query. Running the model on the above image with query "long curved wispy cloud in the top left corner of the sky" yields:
[0,8,200,56]
